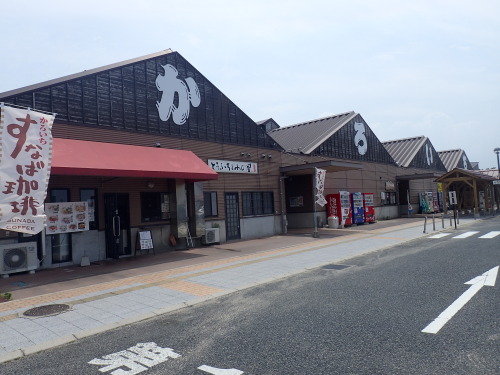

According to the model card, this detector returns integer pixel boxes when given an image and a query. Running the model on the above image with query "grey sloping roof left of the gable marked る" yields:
[268,111,357,154]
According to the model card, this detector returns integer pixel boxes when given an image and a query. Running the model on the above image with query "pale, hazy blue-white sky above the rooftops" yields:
[0,0,500,169]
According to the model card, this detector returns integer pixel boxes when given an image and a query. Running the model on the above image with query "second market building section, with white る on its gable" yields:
[268,111,399,228]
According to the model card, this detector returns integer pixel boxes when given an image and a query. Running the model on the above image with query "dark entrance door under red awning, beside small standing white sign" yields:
[104,193,132,259]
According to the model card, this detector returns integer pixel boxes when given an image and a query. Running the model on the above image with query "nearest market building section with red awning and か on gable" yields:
[0,50,283,274]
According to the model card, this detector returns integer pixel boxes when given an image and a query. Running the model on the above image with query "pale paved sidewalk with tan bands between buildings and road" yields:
[0,218,474,363]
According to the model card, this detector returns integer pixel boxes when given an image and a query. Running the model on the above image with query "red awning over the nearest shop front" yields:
[51,138,217,181]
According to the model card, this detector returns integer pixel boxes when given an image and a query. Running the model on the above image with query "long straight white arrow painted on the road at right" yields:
[422,266,498,334]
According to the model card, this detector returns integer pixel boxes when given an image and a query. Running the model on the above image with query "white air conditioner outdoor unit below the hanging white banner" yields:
[0,242,39,278]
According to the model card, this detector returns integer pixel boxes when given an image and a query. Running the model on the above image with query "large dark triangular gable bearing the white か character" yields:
[0,50,278,148]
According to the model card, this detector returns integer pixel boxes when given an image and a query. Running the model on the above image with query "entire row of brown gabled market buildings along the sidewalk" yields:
[0,50,486,273]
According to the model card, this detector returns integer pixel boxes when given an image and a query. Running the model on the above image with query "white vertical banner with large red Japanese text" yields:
[0,103,54,234]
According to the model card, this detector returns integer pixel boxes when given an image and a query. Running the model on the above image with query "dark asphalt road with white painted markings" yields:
[0,219,500,375]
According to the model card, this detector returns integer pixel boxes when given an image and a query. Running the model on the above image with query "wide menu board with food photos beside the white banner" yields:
[45,202,89,234]
